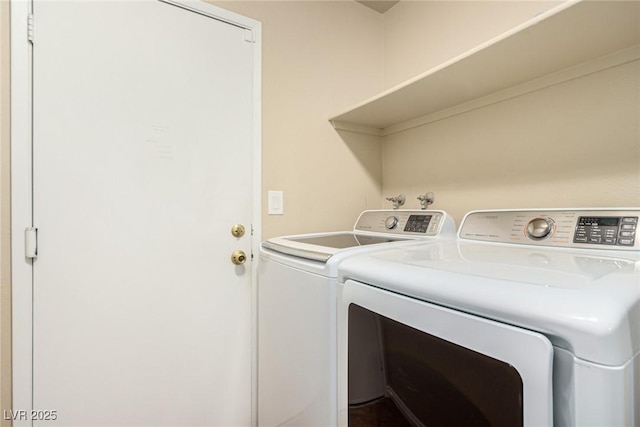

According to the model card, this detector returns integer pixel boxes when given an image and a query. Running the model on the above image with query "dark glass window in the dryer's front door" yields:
[349,305,523,427]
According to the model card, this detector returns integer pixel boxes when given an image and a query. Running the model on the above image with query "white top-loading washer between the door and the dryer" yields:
[258,210,455,427]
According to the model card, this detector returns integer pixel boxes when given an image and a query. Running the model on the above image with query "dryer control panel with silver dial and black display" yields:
[458,208,640,250]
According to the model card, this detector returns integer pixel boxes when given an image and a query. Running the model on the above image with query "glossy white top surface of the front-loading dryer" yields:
[338,241,640,366]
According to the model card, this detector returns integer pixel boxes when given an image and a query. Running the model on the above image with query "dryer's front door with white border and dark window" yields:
[339,280,553,427]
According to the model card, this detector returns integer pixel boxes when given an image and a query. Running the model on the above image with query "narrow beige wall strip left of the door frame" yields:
[0,0,11,427]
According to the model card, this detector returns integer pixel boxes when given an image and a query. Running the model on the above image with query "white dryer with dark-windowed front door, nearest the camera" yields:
[338,208,640,427]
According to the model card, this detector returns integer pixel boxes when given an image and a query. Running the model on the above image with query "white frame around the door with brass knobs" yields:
[10,0,262,427]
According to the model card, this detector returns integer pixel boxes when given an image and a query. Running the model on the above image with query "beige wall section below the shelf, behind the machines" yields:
[383,62,640,223]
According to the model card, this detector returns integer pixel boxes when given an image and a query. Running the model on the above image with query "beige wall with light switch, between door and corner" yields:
[215,1,383,238]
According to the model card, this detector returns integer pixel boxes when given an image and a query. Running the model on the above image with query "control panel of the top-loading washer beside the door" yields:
[354,209,455,237]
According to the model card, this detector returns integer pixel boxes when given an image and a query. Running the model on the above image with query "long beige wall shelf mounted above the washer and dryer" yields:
[330,1,640,136]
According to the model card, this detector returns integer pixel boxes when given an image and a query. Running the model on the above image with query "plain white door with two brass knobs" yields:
[27,1,256,426]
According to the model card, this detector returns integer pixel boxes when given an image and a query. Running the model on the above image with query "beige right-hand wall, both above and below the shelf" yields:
[382,2,640,227]
